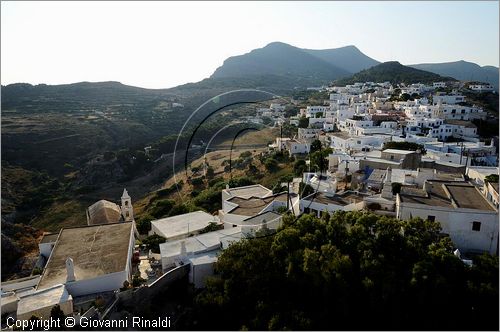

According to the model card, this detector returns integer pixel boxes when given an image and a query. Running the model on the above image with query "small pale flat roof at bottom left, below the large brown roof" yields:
[17,284,72,319]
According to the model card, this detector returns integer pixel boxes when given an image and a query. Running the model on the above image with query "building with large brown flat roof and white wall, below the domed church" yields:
[37,222,135,296]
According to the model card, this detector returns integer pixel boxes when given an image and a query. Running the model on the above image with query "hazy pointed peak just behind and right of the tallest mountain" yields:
[303,45,380,73]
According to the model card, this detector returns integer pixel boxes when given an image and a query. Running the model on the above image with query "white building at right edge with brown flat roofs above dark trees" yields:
[396,180,498,254]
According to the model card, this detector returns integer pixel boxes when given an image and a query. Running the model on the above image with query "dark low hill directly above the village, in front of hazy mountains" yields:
[334,61,455,85]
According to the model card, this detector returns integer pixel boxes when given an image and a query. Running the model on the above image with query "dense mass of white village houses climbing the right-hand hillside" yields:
[269,82,498,256]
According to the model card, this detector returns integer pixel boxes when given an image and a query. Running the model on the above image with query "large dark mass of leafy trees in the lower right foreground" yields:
[184,212,499,330]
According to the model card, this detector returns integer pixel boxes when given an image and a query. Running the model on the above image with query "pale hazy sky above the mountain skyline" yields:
[1,1,499,88]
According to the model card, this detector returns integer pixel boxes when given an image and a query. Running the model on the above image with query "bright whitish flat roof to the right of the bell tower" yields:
[151,211,221,239]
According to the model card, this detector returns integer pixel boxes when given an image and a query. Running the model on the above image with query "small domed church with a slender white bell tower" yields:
[86,189,134,226]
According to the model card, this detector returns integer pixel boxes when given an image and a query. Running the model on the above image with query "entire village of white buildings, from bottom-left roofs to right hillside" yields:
[1,82,499,319]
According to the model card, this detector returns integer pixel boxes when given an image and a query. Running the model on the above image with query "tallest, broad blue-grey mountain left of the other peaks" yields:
[210,42,350,86]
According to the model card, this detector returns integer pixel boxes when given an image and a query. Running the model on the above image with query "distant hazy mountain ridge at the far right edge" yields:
[409,60,498,88]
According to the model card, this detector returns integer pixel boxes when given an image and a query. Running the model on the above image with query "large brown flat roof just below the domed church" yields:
[37,222,132,289]
